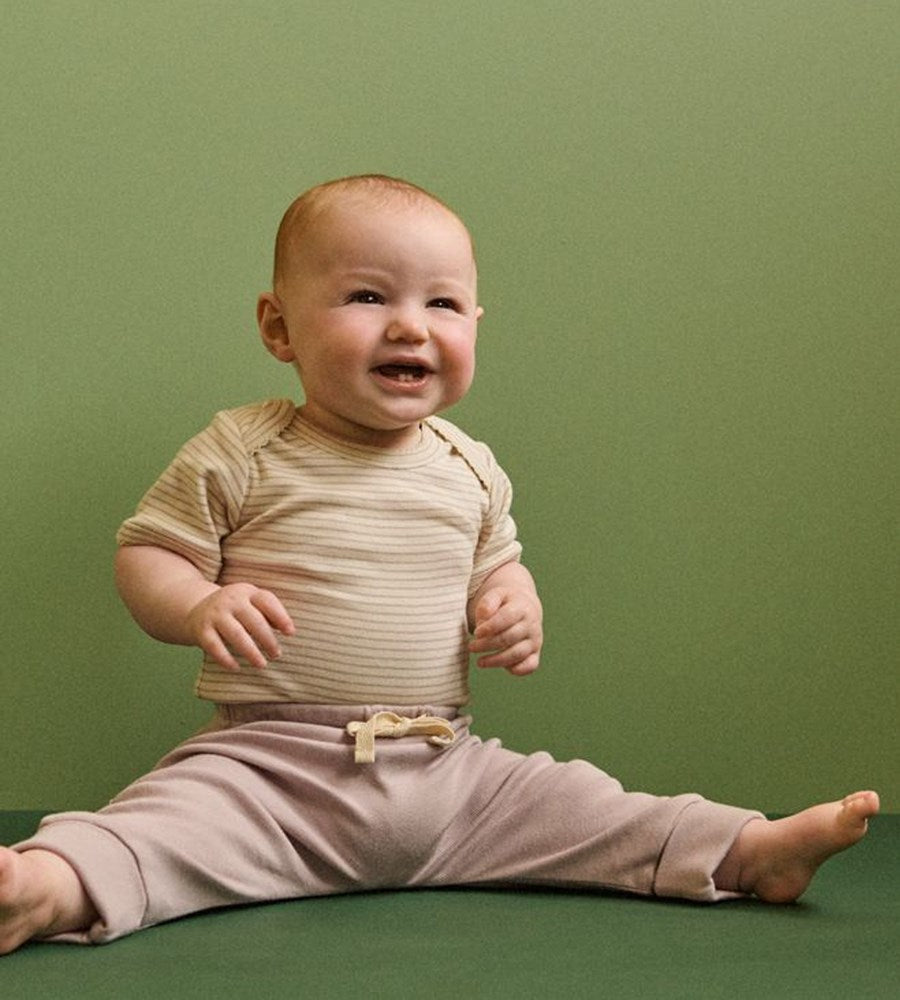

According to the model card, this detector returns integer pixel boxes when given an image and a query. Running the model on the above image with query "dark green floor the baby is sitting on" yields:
[0,813,900,1000]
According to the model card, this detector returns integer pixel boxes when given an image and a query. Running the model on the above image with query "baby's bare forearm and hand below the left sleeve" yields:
[116,545,294,670]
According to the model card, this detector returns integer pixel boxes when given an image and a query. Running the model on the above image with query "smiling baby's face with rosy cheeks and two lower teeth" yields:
[260,199,482,449]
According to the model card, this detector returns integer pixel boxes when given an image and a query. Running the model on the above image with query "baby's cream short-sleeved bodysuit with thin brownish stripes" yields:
[117,400,520,706]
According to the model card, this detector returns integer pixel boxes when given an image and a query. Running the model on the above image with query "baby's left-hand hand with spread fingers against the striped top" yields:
[187,583,294,670]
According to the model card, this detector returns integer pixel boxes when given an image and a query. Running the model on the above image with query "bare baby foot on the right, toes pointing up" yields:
[714,792,879,903]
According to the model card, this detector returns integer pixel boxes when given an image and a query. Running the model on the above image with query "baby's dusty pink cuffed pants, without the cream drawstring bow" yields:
[17,705,760,943]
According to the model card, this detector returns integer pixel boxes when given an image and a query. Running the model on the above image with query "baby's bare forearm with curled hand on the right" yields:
[468,562,544,676]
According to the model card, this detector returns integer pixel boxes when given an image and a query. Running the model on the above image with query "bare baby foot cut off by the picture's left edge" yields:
[0,847,97,955]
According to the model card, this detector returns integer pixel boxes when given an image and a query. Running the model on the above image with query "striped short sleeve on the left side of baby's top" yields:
[116,412,249,581]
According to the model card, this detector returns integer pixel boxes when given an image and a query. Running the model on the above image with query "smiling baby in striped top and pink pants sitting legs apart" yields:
[0,176,878,953]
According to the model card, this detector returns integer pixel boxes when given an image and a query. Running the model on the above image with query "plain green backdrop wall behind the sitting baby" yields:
[0,0,900,811]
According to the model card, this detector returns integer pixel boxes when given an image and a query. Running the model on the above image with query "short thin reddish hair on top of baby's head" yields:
[272,174,471,287]
